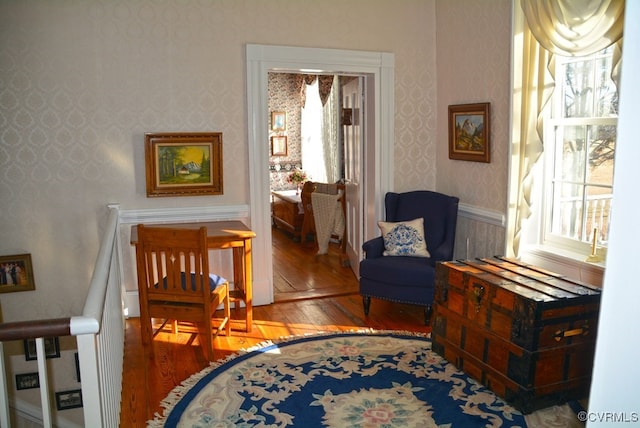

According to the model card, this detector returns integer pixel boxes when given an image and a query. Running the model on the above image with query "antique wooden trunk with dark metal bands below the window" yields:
[432,257,600,413]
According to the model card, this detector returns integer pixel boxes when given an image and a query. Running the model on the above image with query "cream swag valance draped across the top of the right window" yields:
[520,0,624,56]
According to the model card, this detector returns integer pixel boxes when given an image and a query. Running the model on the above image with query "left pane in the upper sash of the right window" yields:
[562,60,594,117]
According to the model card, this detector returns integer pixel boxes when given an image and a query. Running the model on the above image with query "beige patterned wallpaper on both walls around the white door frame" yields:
[0,0,510,320]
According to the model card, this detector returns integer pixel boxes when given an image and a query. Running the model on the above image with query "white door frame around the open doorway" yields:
[246,45,395,305]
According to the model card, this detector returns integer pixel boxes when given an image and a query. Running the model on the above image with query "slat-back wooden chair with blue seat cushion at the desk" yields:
[136,225,230,361]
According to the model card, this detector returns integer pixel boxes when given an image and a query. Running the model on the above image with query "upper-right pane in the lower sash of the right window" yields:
[587,125,616,186]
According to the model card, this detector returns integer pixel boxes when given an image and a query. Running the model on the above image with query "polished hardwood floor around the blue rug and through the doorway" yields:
[120,226,430,427]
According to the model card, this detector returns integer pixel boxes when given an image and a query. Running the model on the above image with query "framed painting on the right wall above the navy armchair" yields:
[449,103,491,163]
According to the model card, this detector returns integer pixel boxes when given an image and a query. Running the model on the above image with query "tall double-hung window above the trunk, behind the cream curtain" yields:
[542,47,618,254]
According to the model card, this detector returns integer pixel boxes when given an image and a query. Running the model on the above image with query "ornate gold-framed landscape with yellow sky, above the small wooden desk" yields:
[145,132,223,197]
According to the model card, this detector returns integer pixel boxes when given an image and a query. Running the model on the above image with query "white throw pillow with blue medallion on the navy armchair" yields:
[378,217,431,257]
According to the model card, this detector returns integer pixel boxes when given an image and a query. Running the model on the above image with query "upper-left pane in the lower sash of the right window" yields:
[556,126,587,182]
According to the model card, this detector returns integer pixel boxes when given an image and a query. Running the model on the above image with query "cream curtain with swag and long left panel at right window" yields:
[507,0,624,256]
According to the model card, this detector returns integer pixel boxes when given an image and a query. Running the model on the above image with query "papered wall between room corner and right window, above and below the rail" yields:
[436,0,511,258]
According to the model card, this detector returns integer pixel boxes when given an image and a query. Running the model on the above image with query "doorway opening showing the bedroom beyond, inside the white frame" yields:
[268,72,365,302]
